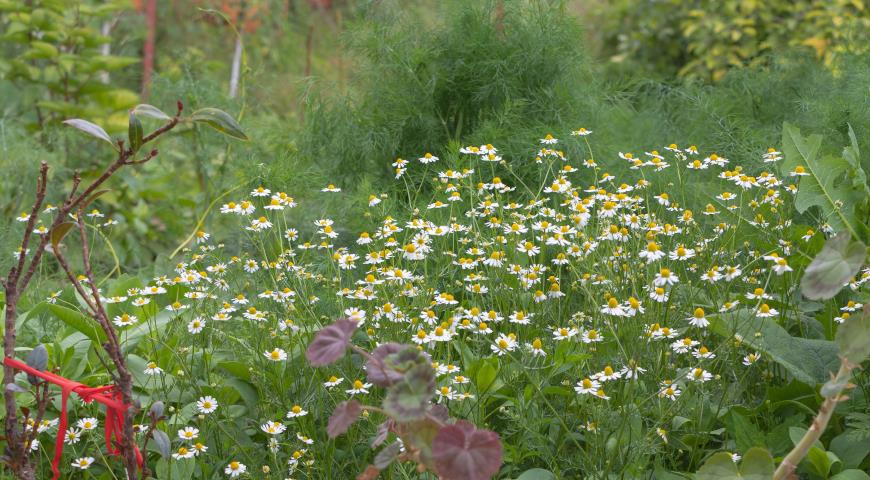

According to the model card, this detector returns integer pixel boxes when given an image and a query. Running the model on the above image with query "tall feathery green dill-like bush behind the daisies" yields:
[299,1,593,184]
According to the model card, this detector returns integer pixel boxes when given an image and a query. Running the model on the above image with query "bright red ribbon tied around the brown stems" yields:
[3,357,143,480]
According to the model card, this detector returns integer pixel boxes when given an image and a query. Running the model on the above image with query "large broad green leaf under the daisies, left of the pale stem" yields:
[710,309,840,385]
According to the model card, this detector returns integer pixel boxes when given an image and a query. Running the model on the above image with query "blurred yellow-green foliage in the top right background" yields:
[592,0,870,81]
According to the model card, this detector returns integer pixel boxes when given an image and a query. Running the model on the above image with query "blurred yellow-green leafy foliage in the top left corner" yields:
[0,0,139,131]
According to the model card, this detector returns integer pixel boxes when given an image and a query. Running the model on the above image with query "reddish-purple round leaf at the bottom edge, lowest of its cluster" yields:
[432,420,501,480]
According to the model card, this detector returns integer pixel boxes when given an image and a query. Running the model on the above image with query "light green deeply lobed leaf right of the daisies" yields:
[780,123,864,238]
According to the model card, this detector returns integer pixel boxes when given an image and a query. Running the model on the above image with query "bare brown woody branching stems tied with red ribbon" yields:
[0,101,184,480]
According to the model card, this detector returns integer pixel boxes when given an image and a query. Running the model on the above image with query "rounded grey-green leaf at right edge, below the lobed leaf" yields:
[801,232,867,300]
